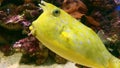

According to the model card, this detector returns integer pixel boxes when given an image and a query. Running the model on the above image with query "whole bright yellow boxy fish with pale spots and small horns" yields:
[30,2,120,68]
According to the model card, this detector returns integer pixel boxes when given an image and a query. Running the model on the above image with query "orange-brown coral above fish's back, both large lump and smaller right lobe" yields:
[62,0,100,29]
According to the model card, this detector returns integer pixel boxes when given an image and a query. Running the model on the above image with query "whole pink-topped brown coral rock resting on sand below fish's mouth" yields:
[13,36,48,64]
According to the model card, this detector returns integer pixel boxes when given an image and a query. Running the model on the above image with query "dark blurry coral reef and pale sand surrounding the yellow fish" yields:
[0,0,120,68]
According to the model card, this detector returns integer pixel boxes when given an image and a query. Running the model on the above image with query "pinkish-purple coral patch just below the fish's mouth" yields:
[13,36,40,53]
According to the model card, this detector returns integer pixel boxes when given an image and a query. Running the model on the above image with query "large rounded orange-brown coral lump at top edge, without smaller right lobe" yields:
[62,0,87,18]
